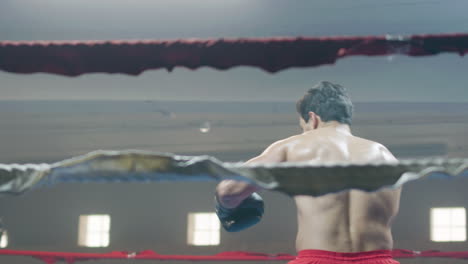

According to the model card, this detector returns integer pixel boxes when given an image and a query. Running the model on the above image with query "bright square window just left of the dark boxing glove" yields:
[187,213,220,246]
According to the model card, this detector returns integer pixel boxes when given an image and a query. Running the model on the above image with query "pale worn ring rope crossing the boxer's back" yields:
[0,150,468,196]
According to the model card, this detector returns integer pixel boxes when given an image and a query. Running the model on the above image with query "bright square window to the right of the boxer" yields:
[431,207,466,242]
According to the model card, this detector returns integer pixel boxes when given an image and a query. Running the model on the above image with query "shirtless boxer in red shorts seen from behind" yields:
[216,82,401,264]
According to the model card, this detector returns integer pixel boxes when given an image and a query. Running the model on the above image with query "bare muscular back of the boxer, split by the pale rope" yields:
[282,126,401,252]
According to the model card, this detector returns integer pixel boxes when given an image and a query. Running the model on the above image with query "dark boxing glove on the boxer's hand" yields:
[215,193,264,232]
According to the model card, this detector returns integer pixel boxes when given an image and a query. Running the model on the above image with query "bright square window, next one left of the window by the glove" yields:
[78,215,110,247]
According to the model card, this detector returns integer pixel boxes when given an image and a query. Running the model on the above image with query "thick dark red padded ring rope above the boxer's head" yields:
[0,34,468,76]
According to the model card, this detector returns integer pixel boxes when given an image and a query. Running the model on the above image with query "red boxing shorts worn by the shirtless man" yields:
[288,250,399,264]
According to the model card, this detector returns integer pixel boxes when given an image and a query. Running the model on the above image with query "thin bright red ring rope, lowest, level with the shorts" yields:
[0,249,468,264]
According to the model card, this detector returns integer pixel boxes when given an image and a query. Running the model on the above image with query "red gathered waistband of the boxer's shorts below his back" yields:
[297,249,392,260]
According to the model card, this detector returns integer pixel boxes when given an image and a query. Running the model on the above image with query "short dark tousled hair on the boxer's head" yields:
[296,81,353,125]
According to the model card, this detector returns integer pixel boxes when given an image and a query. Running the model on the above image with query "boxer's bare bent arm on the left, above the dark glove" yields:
[216,140,286,208]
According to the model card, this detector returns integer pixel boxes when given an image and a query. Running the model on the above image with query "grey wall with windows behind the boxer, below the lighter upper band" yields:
[0,100,468,264]
